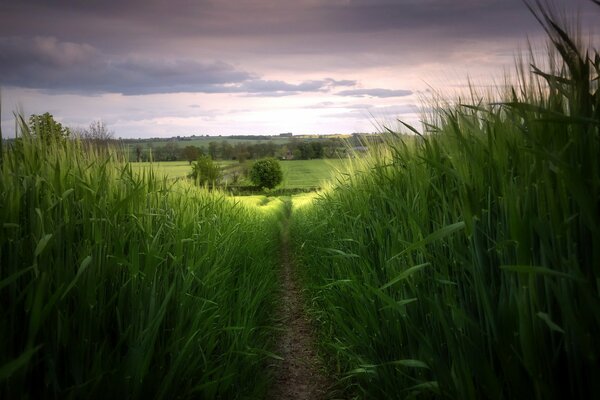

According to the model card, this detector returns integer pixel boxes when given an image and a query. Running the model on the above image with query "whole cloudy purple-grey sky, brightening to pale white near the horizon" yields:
[0,0,600,138]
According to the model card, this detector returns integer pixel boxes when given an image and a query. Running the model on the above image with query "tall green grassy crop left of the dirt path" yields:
[0,118,278,399]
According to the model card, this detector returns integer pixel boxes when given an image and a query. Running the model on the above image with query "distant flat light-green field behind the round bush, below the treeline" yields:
[131,159,347,189]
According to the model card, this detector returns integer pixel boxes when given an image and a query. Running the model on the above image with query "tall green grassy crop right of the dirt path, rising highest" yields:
[292,3,600,399]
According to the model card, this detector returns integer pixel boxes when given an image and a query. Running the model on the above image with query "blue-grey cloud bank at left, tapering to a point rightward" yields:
[0,36,357,96]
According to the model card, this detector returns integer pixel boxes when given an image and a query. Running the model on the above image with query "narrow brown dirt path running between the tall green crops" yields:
[270,203,330,400]
